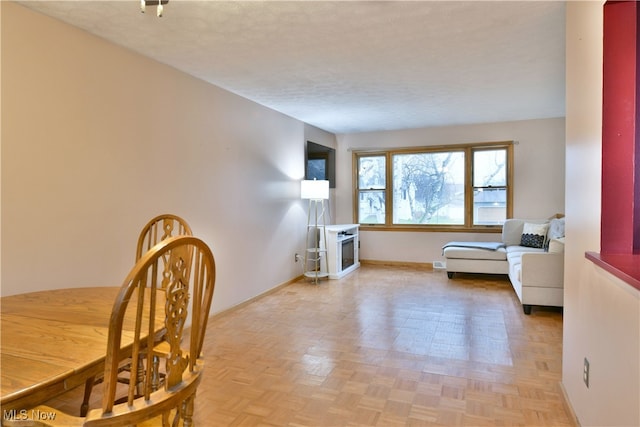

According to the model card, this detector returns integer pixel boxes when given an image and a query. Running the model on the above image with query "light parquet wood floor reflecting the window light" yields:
[50,265,575,426]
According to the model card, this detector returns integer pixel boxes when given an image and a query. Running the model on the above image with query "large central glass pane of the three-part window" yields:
[393,151,464,224]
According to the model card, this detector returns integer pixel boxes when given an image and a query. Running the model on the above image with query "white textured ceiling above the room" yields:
[15,0,565,133]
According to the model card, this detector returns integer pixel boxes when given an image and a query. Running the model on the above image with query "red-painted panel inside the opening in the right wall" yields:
[594,1,640,254]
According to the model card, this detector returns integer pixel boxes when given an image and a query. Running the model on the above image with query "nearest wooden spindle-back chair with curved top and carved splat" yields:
[3,236,215,427]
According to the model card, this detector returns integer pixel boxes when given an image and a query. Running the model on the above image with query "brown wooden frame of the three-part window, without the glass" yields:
[352,141,514,233]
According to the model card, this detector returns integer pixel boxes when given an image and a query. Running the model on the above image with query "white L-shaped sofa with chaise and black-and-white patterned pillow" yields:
[443,217,564,314]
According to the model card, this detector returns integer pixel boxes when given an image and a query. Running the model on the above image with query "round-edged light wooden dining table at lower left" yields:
[0,287,159,411]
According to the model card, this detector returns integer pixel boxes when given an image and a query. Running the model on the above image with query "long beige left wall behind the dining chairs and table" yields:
[1,2,312,312]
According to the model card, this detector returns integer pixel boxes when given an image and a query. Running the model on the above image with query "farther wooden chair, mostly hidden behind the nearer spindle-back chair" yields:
[80,214,193,416]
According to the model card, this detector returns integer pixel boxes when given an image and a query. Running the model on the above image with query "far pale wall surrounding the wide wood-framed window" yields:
[336,118,565,263]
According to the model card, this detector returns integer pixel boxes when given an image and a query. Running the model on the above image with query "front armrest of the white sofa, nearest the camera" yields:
[521,252,564,288]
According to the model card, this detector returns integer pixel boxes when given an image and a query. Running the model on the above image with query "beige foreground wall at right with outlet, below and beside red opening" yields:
[562,1,640,426]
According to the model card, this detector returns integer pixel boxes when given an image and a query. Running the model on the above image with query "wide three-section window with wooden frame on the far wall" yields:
[354,142,513,231]
